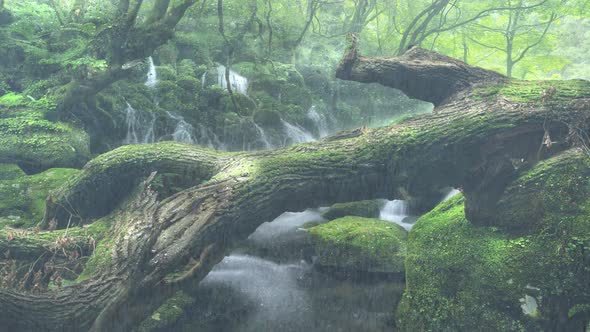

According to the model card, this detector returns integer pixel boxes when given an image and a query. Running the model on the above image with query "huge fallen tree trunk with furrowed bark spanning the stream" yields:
[0,40,590,331]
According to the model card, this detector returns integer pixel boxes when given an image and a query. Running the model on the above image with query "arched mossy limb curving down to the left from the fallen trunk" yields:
[43,142,230,228]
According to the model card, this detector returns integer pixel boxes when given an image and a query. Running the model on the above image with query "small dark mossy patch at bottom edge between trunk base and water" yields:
[136,291,195,332]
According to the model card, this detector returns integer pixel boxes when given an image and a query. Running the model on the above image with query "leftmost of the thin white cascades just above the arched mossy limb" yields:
[123,103,156,144]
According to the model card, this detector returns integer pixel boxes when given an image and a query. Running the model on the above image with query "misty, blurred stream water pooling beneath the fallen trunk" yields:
[175,208,404,332]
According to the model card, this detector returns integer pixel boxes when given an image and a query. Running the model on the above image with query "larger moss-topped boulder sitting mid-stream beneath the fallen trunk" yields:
[309,217,407,275]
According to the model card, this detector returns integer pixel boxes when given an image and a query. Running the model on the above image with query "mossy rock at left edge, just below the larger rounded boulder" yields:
[0,165,79,228]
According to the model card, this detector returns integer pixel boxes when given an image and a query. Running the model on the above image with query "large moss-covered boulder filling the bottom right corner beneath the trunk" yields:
[397,150,590,331]
